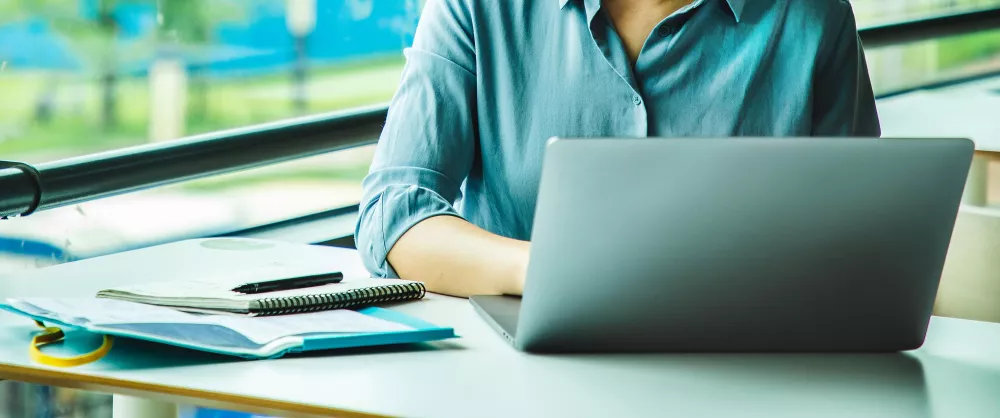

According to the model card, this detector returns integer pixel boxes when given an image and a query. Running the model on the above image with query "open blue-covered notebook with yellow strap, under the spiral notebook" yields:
[0,297,457,360]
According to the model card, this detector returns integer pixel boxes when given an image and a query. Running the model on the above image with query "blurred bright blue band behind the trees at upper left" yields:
[0,0,420,77]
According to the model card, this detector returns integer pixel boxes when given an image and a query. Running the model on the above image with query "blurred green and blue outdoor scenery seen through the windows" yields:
[0,0,1000,418]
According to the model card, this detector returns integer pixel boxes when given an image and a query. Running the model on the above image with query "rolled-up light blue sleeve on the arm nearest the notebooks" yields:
[355,0,476,277]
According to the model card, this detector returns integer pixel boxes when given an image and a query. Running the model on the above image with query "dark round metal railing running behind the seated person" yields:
[0,8,1000,216]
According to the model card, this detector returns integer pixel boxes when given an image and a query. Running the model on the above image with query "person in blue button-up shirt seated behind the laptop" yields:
[356,0,880,296]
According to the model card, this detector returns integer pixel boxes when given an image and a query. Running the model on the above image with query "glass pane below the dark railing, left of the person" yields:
[0,146,374,268]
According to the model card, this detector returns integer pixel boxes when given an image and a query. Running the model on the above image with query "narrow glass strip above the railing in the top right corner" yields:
[851,0,1000,27]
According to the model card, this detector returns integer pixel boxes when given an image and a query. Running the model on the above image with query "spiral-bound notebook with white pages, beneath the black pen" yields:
[97,278,426,316]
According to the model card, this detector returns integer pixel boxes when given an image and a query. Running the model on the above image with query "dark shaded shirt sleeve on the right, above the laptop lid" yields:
[812,1,881,137]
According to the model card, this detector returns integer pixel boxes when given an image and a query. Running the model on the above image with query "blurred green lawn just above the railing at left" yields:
[0,56,403,160]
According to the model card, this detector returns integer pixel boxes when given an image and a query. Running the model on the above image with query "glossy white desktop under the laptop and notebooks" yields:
[0,247,1000,417]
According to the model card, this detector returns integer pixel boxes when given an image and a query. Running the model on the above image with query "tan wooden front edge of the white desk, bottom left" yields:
[0,364,384,418]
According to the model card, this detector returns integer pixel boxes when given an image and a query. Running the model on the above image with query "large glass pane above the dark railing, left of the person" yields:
[0,0,420,162]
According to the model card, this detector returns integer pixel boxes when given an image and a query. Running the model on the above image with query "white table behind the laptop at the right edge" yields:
[878,90,1000,206]
